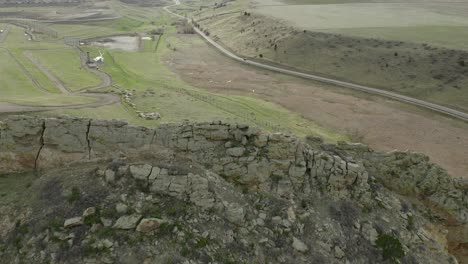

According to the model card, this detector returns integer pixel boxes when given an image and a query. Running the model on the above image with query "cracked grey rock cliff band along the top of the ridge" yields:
[0,116,468,223]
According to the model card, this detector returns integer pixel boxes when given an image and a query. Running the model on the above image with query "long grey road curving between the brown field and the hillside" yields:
[164,0,468,121]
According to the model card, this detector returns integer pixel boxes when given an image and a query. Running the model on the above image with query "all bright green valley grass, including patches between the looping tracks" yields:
[0,1,347,142]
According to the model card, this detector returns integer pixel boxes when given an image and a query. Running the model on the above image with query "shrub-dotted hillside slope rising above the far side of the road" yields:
[195,8,468,111]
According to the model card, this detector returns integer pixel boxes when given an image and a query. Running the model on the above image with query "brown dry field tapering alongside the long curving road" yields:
[164,35,468,177]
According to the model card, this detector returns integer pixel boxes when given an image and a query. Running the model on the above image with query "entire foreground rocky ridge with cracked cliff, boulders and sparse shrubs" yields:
[0,116,468,263]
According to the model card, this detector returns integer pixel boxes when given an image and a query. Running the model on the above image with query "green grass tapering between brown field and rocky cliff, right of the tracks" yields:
[72,32,346,141]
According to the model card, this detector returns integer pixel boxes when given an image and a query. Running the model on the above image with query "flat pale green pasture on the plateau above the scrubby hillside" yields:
[255,0,468,50]
